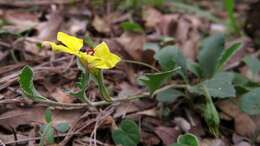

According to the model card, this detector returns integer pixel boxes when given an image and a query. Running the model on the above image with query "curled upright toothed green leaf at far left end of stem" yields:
[18,66,46,101]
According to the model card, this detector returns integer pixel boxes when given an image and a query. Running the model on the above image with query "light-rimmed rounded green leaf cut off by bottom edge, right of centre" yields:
[170,133,199,146]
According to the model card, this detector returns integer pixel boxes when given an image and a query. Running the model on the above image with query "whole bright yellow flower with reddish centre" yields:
[44,32,121,69]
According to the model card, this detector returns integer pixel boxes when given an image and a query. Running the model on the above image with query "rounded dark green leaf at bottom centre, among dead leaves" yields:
[112,120,140,146]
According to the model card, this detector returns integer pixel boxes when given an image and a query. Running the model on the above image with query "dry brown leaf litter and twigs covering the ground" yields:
[0,0,260,146]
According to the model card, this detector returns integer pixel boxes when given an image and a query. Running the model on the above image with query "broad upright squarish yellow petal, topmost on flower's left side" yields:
[57,32,83,51]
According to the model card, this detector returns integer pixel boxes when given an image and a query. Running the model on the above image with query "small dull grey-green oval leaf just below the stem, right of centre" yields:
[156,89,184,103]
